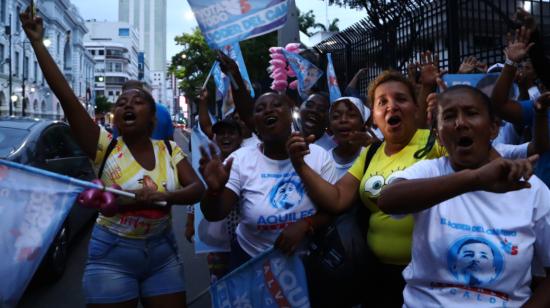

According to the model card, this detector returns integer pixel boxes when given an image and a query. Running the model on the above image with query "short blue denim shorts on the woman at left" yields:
[83,225,185,304]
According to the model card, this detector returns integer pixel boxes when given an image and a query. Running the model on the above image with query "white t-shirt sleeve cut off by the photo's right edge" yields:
[533,181,550,268]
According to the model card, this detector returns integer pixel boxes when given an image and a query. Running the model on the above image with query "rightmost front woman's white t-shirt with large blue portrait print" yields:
[398,157,550,307]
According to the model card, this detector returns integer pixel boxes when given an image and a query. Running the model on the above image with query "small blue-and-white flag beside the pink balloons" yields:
[283,49,323,99]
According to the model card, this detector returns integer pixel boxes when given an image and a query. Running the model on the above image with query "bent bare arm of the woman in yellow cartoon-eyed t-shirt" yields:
[287,133,360,214]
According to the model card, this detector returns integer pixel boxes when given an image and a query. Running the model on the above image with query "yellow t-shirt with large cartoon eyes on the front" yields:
[348,129,446,265]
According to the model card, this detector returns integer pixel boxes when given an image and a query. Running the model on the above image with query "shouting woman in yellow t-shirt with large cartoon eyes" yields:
[287,71,444,307]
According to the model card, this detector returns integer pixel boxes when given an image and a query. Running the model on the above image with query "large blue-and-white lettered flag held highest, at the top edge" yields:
[187,0,288,49]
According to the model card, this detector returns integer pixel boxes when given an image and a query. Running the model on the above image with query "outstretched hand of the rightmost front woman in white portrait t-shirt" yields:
[472,155,538,193]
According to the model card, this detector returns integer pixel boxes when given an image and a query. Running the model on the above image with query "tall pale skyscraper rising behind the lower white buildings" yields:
[118,0,167,103]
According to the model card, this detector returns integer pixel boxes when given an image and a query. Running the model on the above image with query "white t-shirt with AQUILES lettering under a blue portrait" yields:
[226,144,335,257]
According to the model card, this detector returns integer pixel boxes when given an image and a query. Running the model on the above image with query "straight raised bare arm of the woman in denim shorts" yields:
[19,7,99,160]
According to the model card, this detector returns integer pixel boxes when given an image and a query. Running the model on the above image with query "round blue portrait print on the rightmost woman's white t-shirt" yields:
[447,236,504,287]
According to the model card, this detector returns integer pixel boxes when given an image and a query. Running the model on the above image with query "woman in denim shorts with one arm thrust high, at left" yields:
[20,8,204,307]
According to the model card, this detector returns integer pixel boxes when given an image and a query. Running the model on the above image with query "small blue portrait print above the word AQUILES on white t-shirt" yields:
[269,177,304,210]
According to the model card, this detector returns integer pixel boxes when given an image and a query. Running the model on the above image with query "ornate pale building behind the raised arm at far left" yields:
[0,0,95,119]
